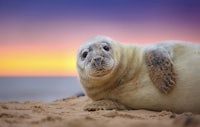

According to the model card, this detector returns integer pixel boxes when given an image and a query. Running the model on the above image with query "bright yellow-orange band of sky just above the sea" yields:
[0,46,76,76]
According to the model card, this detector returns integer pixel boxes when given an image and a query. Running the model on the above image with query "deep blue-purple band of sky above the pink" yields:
[0,0,200,24]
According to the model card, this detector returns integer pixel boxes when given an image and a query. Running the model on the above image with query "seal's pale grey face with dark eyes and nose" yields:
[76,36,114,78]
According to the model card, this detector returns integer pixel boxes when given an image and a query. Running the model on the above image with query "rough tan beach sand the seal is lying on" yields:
[0,96,200,127]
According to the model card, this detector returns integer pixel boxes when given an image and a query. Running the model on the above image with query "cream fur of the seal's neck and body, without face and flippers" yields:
[77,36,200,113]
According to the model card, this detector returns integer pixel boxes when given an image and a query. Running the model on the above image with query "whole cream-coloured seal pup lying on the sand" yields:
[76,36,200,113]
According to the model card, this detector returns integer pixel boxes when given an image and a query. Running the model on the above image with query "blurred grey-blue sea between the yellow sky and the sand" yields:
[0,76,83,102]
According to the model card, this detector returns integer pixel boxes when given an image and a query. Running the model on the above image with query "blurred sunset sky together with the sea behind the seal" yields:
[0,0,200,101]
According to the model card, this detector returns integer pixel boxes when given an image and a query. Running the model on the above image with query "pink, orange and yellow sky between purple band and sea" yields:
[0,21,200,76]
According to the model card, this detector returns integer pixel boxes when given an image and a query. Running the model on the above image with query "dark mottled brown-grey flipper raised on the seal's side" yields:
[145,48,176,94]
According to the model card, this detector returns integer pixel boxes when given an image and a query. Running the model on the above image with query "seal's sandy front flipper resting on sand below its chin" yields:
[84,100,127,111]
